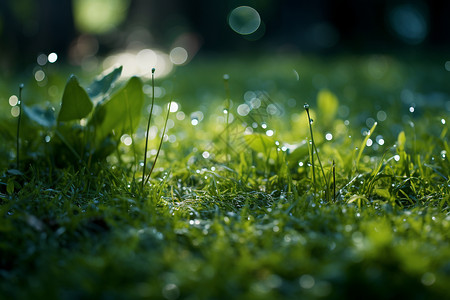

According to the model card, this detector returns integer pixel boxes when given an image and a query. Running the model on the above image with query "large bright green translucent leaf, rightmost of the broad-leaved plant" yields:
[92,77,144,145]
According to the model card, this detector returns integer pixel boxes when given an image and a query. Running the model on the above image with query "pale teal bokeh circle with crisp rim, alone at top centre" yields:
[228,6,261,35]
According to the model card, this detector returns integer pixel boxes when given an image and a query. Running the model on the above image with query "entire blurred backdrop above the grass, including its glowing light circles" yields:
[0,0,450,75]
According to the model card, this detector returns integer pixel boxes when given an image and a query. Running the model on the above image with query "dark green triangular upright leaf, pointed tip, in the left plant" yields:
[58,75,93,122]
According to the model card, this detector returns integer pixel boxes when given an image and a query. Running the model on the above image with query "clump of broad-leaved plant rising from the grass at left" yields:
[6,67,144,166]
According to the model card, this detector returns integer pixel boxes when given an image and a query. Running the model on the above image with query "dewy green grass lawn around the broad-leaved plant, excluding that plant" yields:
[0,52,450,299]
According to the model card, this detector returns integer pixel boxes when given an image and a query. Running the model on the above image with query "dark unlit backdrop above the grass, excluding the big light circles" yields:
[0,0,450,70]
